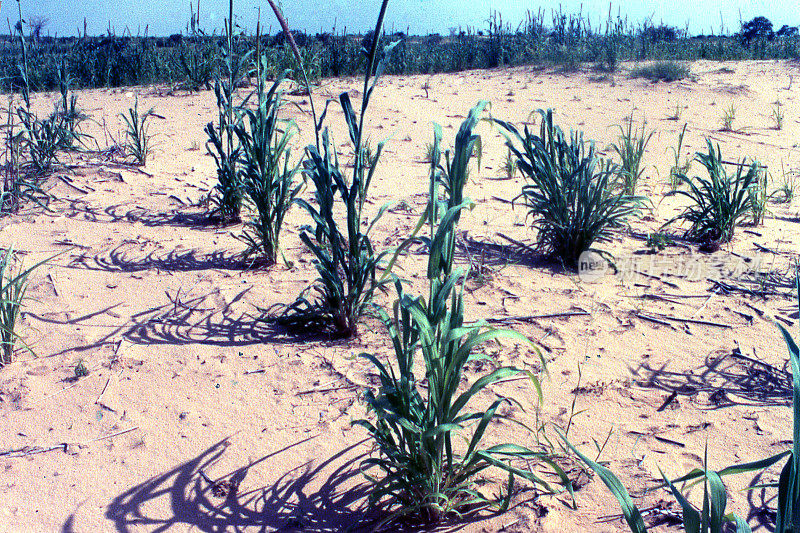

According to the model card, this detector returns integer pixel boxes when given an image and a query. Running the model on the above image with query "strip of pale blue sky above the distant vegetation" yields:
[12,0,800,36]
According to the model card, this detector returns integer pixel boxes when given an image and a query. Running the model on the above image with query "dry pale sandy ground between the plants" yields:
[0,61,800,532]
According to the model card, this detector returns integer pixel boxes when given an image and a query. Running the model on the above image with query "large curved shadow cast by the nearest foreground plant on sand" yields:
[95,437,382,532]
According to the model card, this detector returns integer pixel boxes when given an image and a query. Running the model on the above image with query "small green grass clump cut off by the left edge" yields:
[0,248,42,368]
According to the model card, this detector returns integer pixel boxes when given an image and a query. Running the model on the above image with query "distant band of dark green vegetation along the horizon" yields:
[0,10,800,91]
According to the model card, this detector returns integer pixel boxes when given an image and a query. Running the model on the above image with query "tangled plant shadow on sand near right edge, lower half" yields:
[630,348,792,409]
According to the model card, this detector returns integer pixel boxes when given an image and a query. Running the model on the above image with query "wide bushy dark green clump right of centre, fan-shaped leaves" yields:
[497,110,646,266]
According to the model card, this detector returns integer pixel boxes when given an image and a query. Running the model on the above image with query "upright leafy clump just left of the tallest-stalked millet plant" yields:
[235,68,302,264]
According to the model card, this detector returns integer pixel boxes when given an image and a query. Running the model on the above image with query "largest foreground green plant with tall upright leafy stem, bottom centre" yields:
[355,103,568,530]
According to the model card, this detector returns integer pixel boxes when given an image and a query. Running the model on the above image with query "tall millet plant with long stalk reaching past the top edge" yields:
[276,0,393,336]
